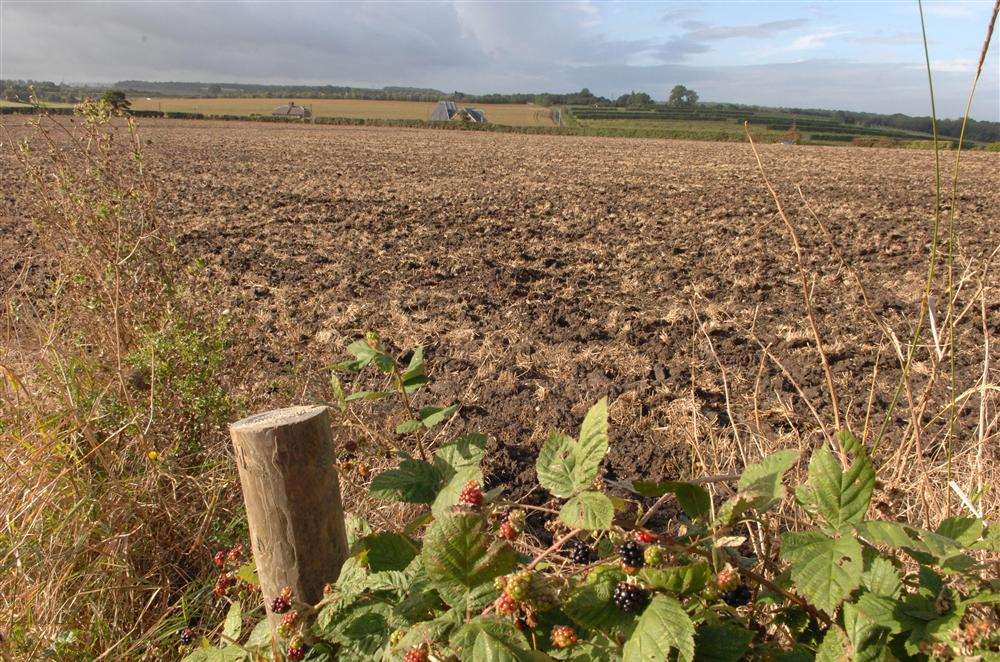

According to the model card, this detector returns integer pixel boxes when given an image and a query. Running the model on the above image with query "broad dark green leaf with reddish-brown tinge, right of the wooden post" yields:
[421,514,517,609]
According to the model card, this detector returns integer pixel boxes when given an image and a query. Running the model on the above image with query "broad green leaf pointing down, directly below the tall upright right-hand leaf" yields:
[781,531,862,614]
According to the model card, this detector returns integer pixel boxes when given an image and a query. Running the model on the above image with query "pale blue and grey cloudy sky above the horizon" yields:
[0,0,1000,121]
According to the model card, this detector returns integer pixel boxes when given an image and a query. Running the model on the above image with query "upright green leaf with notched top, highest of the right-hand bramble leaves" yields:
[797,446,875,531]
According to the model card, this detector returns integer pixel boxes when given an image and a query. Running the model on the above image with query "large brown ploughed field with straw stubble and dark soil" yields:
[0,120,1000,496]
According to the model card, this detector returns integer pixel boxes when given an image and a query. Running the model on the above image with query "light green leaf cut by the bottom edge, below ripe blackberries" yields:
[622,595,694,662]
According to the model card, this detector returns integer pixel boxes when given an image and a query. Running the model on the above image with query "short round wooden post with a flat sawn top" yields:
[229,406,348,633]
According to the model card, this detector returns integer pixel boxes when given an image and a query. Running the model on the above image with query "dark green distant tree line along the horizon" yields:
[0,80,1000,142]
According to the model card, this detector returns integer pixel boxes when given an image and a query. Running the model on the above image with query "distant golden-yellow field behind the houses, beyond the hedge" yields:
[129,97,553,126]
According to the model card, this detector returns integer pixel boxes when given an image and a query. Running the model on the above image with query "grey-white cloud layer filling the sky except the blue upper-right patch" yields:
[0,0,1000,120]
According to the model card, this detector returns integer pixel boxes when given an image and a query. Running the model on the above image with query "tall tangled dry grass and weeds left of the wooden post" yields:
[0,98,242,660]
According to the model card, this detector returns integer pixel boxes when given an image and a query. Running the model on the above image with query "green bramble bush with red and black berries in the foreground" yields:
[185,335,1000,662]
